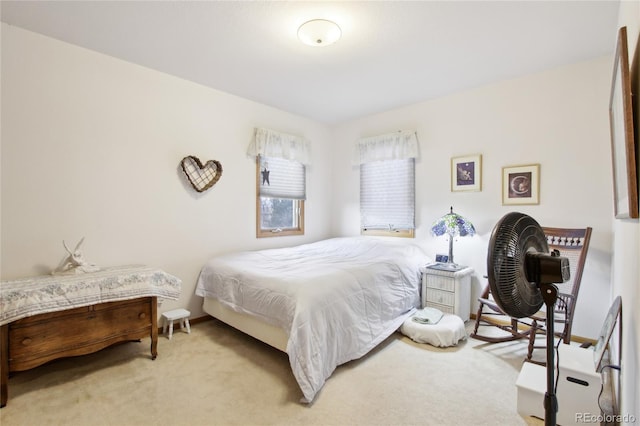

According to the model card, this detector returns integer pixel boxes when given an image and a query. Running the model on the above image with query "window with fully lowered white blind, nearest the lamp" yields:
[360,158,415,237]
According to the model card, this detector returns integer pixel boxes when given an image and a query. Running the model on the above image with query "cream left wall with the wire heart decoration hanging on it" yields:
[1,23,331,317]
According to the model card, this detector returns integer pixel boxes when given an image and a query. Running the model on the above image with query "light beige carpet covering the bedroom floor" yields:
[0,320,543,426]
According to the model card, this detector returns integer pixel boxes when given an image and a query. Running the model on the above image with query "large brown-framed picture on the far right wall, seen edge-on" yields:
[609,27,638,219]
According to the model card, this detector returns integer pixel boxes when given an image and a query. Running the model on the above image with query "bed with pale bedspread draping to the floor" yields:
[195,237,429,403]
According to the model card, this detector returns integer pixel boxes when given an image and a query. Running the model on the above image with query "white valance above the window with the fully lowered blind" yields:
[353,131,418,164]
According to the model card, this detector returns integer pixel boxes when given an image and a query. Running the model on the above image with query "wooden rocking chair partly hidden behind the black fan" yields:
[471,227,592,361]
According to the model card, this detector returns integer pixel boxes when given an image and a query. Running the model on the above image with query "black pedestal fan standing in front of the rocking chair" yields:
[487,212,570,426]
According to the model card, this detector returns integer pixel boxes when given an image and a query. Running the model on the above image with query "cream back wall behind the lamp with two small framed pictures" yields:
[333,57,613,338]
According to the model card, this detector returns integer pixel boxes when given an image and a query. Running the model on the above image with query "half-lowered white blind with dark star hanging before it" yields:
[258,156,306,200]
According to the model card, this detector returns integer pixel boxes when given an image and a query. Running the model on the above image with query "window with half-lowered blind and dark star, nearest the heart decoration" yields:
[256,155,306,238]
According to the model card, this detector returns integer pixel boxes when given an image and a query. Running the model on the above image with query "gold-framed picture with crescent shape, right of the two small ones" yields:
[502,164,540,205]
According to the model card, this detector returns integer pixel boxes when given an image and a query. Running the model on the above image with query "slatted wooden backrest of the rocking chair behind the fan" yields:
[542,226,592,338]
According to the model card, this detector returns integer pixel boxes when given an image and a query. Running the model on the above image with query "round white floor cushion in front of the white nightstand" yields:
[400,314,467,347]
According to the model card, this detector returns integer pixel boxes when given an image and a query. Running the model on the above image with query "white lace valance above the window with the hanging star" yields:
[247,128,311,165]
